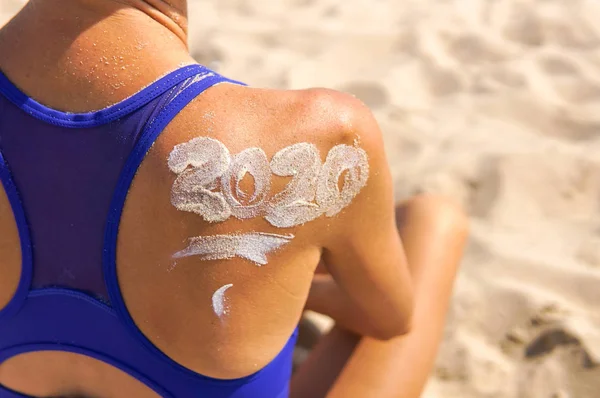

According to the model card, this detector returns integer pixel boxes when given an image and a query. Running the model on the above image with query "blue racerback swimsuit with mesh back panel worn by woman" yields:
[0,65,296,398]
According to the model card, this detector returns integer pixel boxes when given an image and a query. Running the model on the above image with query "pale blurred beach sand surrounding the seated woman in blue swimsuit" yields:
[0,0,600,398]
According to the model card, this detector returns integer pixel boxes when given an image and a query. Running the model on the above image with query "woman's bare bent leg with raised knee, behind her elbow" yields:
[291,195,468,398]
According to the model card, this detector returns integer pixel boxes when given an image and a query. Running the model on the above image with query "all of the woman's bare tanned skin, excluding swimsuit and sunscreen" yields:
[0,0,467,398]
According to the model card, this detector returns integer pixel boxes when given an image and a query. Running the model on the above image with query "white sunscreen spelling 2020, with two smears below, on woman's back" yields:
[168,137,369,317]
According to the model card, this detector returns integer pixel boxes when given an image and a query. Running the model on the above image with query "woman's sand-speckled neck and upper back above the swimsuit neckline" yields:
[0,0,194,112]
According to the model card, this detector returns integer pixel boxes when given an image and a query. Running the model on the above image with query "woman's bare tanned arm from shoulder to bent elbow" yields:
[316,91,413,340]
